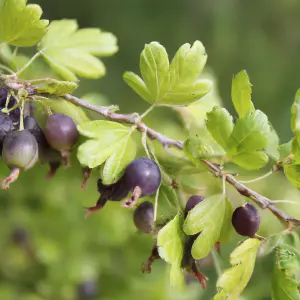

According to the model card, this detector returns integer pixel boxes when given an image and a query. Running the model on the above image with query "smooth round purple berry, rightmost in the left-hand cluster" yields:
[44,114,79,151]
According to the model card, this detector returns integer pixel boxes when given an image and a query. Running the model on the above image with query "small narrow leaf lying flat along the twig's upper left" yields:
[31,78,78,96]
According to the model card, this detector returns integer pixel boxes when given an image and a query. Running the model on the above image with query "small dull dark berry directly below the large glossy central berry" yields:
[133,201,154,233]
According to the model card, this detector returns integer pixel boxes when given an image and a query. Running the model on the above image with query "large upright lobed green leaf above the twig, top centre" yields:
[123,41,211,106]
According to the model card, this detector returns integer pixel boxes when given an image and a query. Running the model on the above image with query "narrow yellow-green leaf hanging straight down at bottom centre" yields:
[157,215,184,288]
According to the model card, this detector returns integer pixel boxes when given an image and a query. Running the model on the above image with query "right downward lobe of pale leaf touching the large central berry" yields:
[101,132,136,184]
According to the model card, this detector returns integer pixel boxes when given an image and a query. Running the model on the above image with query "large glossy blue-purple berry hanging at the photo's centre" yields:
[123,158,161,197]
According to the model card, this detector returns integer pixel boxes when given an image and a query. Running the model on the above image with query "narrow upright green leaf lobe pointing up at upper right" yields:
[231,71,254,119]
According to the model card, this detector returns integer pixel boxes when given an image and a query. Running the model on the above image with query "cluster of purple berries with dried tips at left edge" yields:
[0,88,79,189]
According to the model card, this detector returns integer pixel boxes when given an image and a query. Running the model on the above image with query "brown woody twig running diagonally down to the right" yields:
[64,94,300,228]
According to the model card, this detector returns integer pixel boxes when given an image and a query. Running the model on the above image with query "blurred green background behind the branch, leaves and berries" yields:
[0,0,300,300]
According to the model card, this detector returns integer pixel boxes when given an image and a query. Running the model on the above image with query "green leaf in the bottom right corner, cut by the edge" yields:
[271,244,300,300]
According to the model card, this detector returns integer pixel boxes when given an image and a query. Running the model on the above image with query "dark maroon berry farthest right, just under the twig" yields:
[232,203,260,237]
